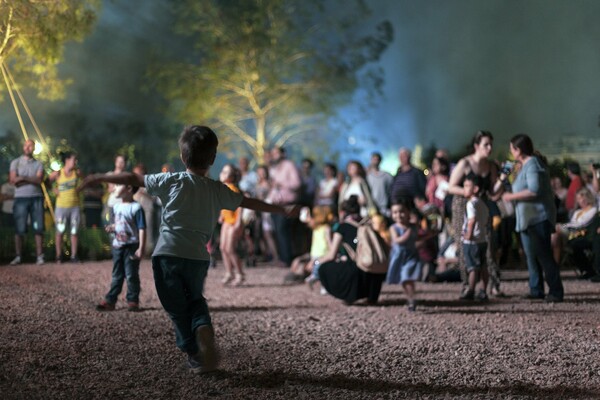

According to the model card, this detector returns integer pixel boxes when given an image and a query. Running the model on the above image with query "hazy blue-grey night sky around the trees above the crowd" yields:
[0,0,600,169]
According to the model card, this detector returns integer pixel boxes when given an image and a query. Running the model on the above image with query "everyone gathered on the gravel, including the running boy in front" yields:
[2,127,600,371]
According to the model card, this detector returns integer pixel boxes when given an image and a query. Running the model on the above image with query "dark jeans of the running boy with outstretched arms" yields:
[152,256,211,354]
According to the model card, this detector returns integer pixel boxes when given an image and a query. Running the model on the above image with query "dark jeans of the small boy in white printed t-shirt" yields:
[104,243,140,304]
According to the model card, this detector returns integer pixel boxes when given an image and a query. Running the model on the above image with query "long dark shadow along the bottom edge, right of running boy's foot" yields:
[211,370,598,399]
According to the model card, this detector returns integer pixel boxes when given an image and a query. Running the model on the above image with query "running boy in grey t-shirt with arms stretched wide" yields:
[82,126,297,372]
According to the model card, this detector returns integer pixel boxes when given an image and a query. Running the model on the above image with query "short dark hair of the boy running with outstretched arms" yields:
[179,125,219,169]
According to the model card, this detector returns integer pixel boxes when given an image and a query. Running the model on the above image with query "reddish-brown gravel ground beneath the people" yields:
[0,260,600,399]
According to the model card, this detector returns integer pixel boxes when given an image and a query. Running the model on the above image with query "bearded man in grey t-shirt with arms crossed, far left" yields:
[9,139,44,265]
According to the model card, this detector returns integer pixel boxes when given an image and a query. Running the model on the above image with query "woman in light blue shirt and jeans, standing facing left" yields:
[502,133,564,303]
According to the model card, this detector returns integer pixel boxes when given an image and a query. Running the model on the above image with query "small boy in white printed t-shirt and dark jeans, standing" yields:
[96,185,146,311]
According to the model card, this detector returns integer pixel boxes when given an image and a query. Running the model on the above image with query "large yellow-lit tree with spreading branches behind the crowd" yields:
[149,0,393,161]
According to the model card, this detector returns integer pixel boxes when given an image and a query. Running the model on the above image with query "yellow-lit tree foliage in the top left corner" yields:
[0,0,99,100]
